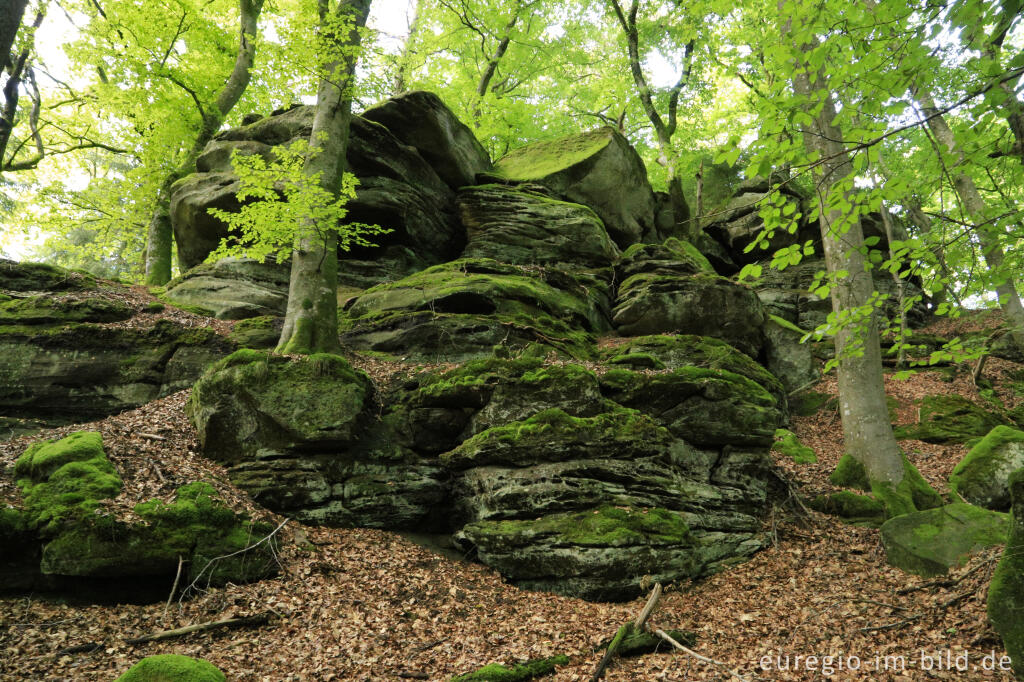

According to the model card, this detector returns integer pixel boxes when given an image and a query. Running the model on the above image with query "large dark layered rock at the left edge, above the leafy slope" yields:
[0,263,232,425]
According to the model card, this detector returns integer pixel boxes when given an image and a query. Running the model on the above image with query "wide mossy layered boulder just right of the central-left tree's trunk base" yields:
[340,259,609,361]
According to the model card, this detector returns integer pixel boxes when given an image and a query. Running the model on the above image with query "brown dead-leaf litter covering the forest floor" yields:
[0,311,1020,682]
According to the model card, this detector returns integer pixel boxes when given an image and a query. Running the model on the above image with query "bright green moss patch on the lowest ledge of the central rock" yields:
[470,506,695,547]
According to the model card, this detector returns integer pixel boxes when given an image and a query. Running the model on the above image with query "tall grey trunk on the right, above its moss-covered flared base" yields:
[779,13,903,487]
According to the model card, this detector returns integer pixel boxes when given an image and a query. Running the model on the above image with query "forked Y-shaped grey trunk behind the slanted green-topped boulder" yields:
[608,0,700,240]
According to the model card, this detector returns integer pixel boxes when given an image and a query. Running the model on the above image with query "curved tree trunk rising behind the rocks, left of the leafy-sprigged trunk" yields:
[145,0,265,286]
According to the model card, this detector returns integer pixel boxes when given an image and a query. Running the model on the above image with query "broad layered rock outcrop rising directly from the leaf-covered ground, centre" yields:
[189,348,784,599]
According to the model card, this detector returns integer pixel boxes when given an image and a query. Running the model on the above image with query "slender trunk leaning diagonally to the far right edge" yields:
[914,88,1024,349]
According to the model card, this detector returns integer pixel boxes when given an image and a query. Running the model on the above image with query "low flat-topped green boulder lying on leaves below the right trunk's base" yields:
[882,502,1010,576]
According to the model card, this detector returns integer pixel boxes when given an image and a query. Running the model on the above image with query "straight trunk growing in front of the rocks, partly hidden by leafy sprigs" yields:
[278,0,371,354]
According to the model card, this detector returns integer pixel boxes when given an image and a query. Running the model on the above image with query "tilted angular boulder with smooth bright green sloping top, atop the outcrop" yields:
[495,128,655,248]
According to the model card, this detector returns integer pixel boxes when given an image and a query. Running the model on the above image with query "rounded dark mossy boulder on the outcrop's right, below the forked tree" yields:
[612,272,765,357]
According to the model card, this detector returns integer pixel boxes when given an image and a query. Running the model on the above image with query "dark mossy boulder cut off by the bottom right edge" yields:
[988,471,1024,679]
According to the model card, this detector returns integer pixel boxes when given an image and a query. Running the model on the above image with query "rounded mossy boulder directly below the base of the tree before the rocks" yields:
[187,349,373,463]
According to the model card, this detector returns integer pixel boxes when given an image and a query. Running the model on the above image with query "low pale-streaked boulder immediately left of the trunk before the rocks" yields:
[164,258,289,319]
